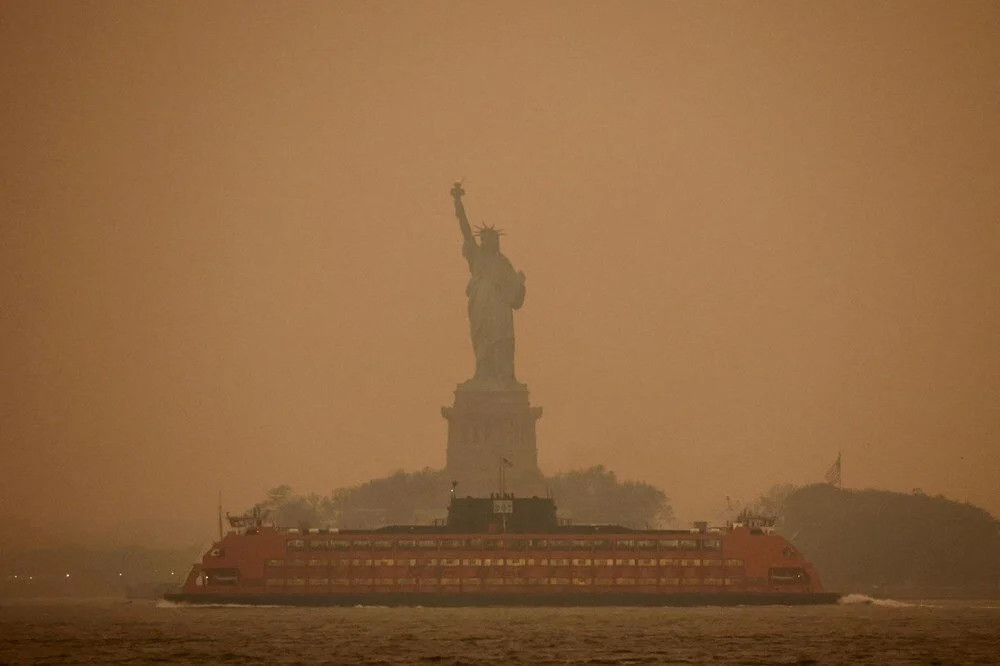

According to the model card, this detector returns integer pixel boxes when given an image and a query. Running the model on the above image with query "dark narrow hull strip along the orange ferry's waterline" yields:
[164,592,840,607]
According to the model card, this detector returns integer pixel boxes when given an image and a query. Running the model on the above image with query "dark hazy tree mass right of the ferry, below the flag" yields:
[758,484,1000,597]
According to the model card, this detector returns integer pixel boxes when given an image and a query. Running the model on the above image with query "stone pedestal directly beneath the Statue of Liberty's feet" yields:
[441,385,544,497]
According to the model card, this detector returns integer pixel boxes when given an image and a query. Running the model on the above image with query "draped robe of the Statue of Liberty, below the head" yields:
[462,239,524,385]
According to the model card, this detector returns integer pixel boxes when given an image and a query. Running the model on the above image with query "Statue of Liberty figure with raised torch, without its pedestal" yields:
[451,183,524,389]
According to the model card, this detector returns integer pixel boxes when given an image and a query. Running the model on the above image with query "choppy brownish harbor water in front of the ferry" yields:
[0,595,1000,664]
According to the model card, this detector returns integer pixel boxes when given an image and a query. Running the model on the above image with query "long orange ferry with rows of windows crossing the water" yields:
[166,494,839,606]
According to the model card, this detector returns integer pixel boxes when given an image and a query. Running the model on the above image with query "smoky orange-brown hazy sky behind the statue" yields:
[0,0,1000,536]
